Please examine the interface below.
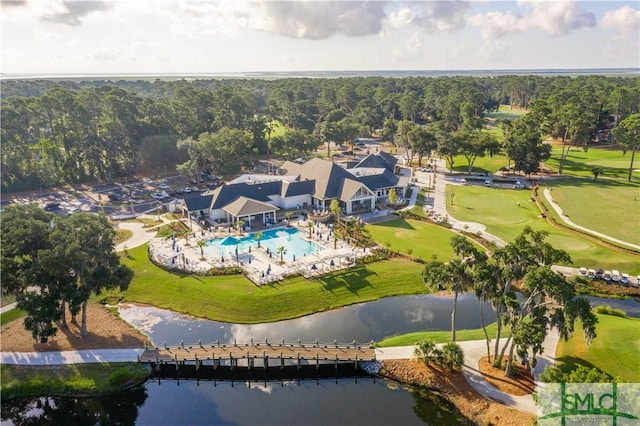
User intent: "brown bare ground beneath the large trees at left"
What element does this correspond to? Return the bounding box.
[0,303,148,352]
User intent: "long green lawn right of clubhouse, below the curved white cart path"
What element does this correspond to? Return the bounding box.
[447,185,640,275]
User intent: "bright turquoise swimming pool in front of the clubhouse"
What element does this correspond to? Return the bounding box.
[205,228,322,260]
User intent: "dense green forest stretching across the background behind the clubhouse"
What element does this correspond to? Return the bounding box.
[1,76,640,190]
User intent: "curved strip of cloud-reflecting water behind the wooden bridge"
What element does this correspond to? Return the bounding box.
[120,294,495,345]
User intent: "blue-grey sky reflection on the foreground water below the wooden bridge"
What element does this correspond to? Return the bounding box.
[132,379,461,425]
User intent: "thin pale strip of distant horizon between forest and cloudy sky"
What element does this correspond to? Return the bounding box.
[0,67,640,80]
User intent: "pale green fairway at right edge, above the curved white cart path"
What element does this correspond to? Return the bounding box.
[540,178,640,244]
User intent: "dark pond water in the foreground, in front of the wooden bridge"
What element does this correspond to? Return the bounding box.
[2,379,460,426]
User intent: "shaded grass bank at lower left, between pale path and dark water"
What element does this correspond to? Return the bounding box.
[0,363,149,400]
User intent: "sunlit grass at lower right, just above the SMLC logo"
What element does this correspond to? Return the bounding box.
[556,314,640,383]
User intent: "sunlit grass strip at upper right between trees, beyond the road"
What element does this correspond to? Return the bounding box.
[545,144,640,182]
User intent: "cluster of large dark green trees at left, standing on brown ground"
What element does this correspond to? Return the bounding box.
[0,204,133,343]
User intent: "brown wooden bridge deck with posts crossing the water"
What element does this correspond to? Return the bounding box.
[139,342,376,366]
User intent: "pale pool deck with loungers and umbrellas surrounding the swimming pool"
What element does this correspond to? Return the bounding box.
[149,220,370,285]
